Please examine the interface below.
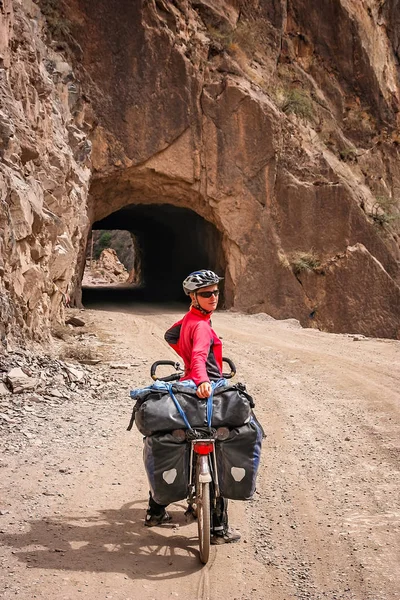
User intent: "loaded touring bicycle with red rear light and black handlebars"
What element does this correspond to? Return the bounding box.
[150,357,236,564]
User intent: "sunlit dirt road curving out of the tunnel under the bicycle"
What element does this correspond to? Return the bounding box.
[0,306,400,600]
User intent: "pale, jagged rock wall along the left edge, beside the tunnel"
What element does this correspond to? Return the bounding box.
[0,0,91,343]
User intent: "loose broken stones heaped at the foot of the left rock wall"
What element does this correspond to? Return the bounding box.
[0,350,129,454]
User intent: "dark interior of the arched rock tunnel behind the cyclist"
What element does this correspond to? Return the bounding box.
[82,204,225,307]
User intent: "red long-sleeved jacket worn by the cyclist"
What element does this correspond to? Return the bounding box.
[164,306,222,385]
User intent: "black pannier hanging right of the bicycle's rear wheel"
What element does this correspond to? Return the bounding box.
[216,418,264,500]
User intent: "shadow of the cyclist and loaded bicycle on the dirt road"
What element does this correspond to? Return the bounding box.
[2,501,202,581]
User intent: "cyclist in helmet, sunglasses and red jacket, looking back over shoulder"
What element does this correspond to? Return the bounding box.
[145,269,240,544]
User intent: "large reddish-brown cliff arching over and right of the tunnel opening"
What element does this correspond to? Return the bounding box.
[68,0,400,337]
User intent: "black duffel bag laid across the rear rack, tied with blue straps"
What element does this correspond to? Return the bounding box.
[133,383,254,436]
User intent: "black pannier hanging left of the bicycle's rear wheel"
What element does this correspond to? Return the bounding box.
[143,433,190,504]
